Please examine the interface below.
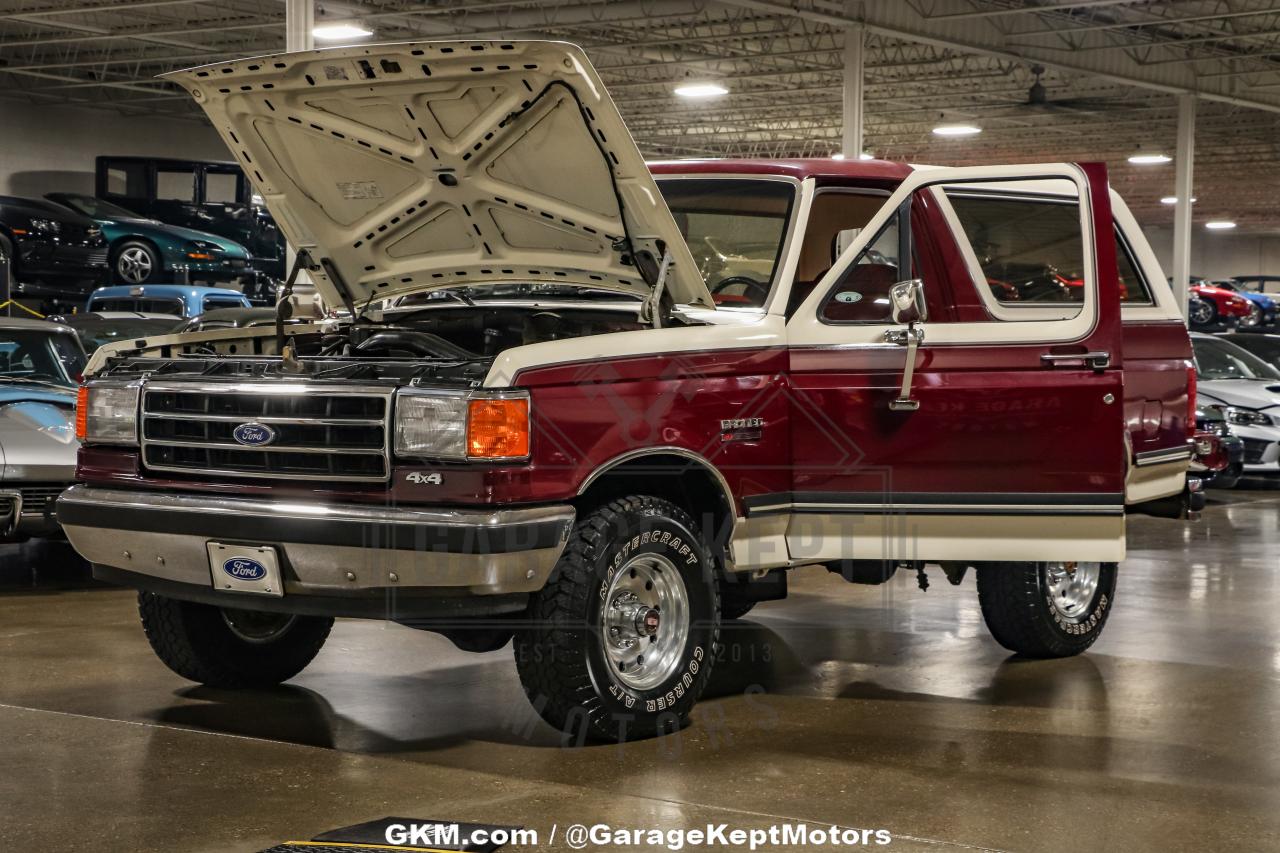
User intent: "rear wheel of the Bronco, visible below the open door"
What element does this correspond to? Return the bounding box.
[978,562,1116,657]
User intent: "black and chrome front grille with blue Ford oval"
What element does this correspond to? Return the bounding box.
[142,384,390,482]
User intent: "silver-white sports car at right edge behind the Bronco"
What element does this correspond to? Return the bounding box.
[1192,333,1280,474]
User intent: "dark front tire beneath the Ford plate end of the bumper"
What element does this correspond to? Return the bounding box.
[138,592,333,688]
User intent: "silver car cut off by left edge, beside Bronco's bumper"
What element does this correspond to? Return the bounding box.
[0,316,86,542]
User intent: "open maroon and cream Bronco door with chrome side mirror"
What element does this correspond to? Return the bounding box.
[773,165,1125,561]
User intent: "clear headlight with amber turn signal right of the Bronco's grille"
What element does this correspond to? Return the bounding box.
[396,391,530,460]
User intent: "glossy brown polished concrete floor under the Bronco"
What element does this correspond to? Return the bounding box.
[0,484,1280,852]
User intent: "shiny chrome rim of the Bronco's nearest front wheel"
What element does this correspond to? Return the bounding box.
[600,553,690,690]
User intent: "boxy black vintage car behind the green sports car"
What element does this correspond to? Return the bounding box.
[95,156,284,292]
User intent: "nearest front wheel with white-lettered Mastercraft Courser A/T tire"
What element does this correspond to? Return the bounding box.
[515,496,719,742]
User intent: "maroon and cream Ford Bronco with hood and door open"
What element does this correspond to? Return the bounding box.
[59,41,1194,738]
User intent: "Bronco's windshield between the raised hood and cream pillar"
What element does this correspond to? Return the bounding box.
[658,178,795,309]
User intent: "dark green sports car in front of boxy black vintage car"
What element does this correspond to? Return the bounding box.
[45,192,259,289]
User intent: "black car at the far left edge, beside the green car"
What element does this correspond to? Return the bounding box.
[0,196,106,302]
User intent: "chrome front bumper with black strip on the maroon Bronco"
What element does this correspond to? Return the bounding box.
[58,485,575,604]
